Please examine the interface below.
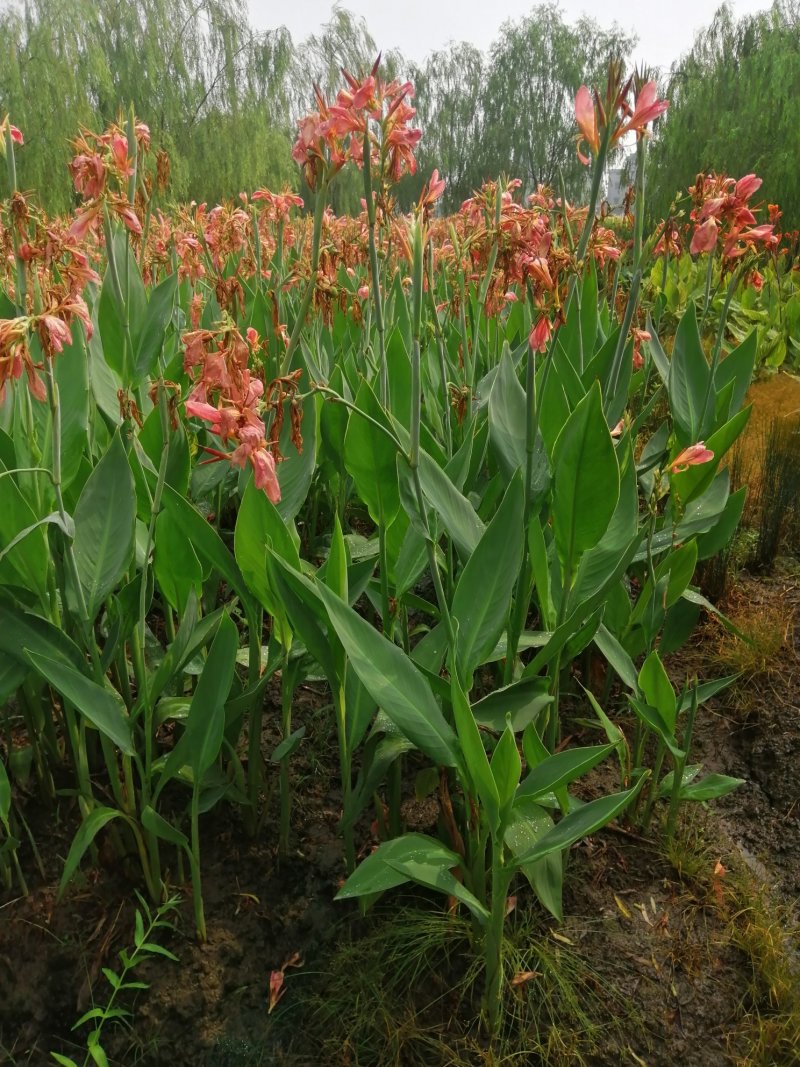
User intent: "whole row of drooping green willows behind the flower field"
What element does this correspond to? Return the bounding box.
[0,0,800,228]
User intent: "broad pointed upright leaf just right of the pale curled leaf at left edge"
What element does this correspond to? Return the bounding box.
[75,430,137,619]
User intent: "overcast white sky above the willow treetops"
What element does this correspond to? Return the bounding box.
[249,0,771,77]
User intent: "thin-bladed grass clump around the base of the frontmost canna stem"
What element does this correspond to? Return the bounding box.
[266,905,624,1067]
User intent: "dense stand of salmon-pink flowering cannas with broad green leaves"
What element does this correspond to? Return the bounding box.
[0,50,771,1032]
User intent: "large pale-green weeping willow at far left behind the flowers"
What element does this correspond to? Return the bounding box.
[0,0,293,210]
